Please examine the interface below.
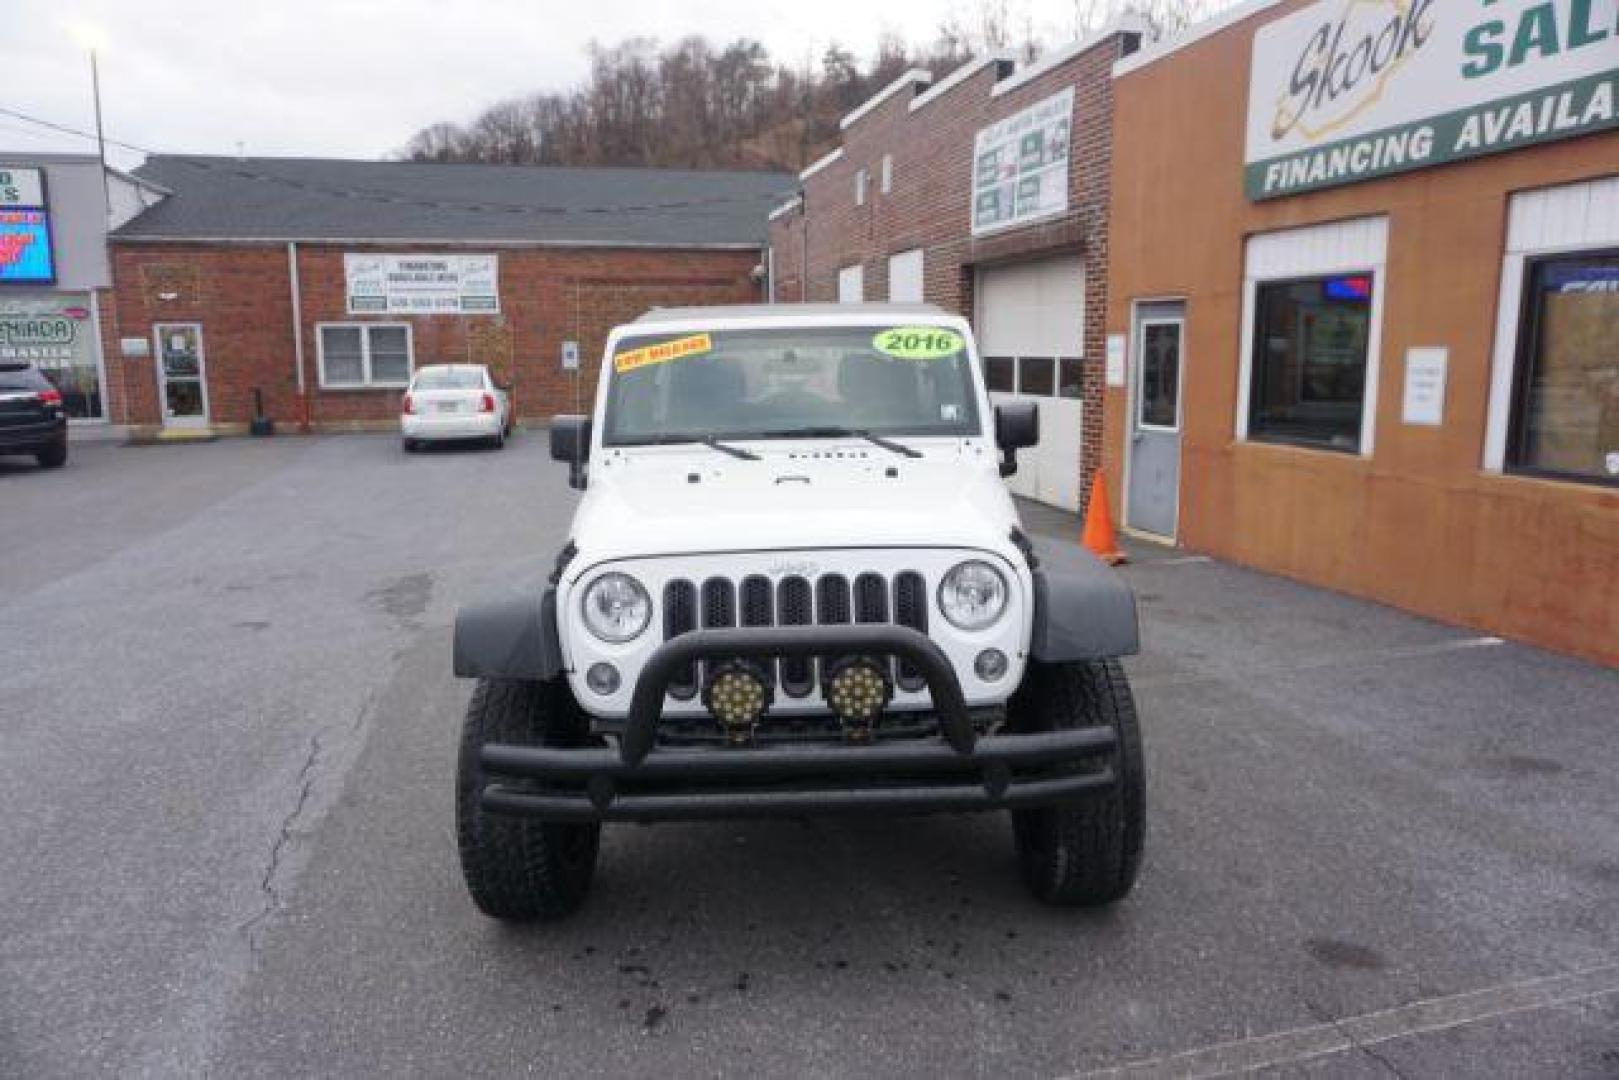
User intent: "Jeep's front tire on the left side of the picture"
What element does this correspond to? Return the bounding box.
[455,678,601,923]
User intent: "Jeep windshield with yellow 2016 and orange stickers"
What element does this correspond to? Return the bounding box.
[602,324,981,447]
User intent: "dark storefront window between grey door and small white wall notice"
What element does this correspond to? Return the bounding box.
[1248,274,1373,452]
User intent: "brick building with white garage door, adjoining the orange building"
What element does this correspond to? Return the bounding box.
[769,19,1143,510]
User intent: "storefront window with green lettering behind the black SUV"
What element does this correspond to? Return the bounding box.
[0,293,107,419]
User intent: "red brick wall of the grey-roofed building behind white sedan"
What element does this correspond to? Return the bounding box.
[108,241,761,427]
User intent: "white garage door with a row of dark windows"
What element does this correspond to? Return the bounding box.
[976,257,1085,510]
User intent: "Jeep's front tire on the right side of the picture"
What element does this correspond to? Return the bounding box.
[1010,661,1146,907]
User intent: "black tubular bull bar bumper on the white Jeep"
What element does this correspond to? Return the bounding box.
[481,625,1117,823]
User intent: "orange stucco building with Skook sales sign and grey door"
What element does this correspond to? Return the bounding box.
[1104,0,1619,664]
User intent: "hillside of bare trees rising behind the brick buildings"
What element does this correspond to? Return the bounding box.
[400,0,1229,170]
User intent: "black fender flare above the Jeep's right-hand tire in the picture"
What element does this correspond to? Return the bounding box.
[1030,539,1141,664]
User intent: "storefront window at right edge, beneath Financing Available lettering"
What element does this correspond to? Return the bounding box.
[1509,251,1619,484]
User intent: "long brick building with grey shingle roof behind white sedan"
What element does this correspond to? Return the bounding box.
[107,155,792,431]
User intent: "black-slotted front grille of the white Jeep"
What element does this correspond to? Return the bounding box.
[664,570,928,701]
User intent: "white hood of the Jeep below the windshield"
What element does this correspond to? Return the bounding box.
[573,452,1017,570]
